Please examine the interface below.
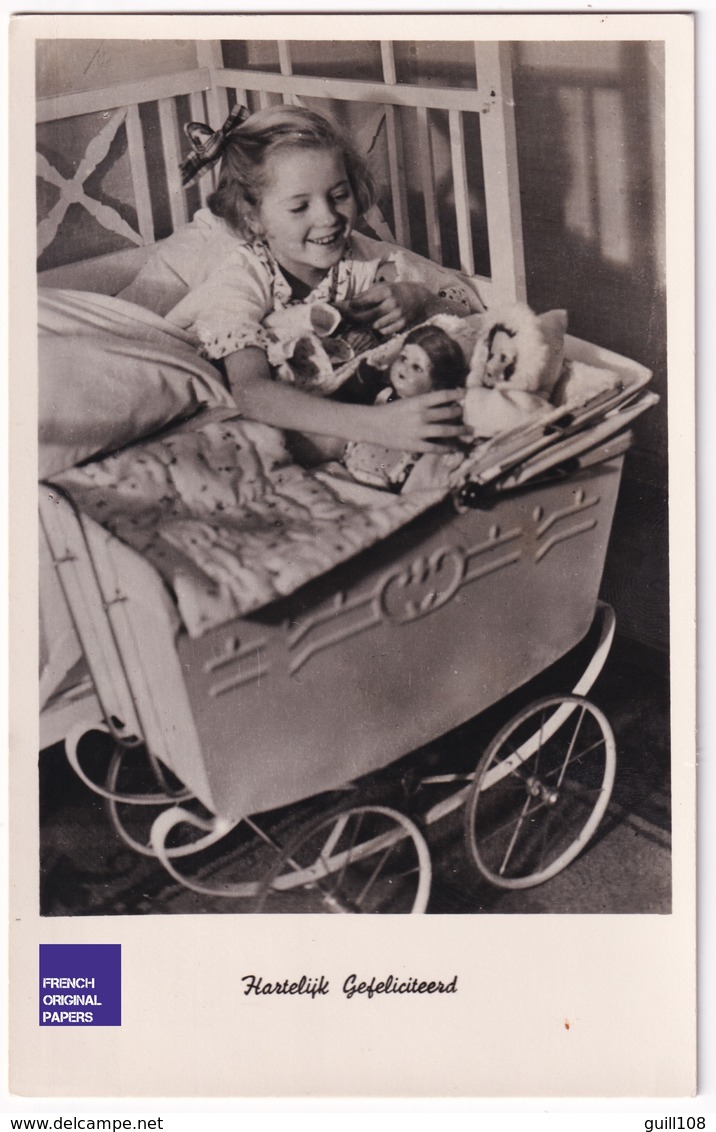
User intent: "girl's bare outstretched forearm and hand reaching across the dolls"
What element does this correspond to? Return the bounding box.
[224,346,472,452]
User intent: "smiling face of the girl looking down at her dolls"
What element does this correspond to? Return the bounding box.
[251,148,357,288]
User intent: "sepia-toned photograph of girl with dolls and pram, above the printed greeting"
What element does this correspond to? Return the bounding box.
[36,30,671,916]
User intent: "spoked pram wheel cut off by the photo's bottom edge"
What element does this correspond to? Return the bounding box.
[256,806,432,915]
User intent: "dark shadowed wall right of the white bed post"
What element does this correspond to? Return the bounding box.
[515,43,668,648]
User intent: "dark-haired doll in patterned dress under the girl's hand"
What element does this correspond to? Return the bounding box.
[343,325,467,491]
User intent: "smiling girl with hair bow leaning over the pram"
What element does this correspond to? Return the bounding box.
[121,105,483,455]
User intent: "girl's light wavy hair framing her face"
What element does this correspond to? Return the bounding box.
[207,105,373,235]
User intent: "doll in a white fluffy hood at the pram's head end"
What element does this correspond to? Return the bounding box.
[465,303,566,438]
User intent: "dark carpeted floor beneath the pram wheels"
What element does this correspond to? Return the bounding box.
[40,638,671,916]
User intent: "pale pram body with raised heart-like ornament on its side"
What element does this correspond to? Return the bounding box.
[43,441,621,818]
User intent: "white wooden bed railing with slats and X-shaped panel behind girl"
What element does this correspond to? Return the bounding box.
[37,41,525,301]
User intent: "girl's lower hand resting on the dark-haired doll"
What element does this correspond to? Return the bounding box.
[370,389,473,452]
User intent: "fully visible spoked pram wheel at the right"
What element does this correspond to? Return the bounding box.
[465,696,616,889]
